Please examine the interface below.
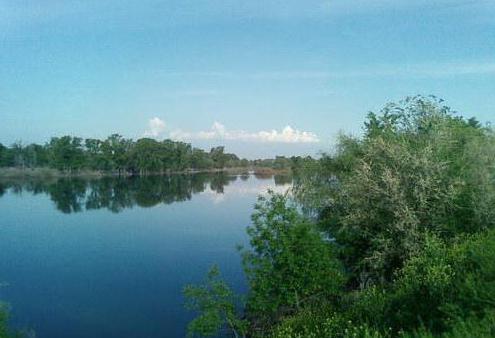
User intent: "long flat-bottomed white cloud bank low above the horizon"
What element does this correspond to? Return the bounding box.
[170,122,319,143]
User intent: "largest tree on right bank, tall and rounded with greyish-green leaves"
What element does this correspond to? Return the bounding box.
[295,97,495,286]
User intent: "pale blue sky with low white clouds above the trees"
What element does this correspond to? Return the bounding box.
[0,0,495,158]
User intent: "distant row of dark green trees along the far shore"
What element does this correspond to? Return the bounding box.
[0,134,311,175]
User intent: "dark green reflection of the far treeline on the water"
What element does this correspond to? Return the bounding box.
[0,173,252,214]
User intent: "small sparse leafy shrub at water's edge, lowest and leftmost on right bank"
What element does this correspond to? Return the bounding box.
[184,266,247,337]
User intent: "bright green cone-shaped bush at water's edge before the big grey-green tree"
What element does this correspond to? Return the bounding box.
[242,193,344,322]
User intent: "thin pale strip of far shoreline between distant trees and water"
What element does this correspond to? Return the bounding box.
[0,167,291,178]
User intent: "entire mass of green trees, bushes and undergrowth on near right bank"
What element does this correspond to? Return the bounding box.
[185,96,495,338]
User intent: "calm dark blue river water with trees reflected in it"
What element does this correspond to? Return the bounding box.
[0,174,290,338]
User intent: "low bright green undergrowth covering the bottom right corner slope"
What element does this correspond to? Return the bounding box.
[269,230,495,337]
